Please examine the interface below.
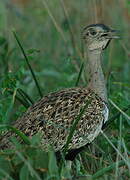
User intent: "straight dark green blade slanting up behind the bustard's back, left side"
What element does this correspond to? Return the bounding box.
[13,31,42,98]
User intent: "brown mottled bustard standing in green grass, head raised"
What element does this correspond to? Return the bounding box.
[0,24,118,160]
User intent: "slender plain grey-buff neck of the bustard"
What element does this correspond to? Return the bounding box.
[87,50,107,102]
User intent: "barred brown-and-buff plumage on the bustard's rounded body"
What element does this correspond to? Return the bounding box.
[0,88,107,151]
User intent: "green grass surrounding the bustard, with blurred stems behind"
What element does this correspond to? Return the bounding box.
[0,0,130,180]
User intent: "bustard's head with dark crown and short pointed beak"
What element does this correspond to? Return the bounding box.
[83,24,119,51]
